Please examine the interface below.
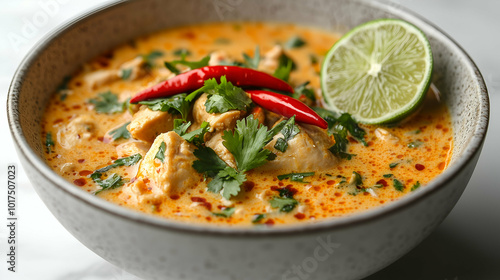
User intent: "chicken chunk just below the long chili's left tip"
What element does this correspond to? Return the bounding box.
[127,105,175,143]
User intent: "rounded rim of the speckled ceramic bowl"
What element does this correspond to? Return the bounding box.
[7,0,490,237]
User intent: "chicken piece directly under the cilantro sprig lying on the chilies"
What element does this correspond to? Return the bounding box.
[193,93,245,132]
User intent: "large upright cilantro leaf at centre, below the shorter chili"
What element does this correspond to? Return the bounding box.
[222,115,271,172]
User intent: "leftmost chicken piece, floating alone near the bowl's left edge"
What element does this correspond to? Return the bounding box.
[57,114,97,149]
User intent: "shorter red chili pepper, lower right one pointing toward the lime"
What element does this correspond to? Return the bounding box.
[246,90,328,129]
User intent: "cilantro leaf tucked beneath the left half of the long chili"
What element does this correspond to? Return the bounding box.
[139,93,191,120]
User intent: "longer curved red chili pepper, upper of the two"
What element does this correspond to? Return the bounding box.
[130,66,293,103]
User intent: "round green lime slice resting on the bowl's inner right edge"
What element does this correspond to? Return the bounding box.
[321,19,433,124]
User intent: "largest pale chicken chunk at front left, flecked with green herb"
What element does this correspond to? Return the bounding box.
[124,131,202,203]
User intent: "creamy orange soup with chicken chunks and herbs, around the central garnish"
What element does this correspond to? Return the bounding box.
[42,23,453,226]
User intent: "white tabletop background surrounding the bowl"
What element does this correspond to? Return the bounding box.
[0,0,500,280]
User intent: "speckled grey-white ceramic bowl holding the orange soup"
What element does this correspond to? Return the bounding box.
[7,0,489,279]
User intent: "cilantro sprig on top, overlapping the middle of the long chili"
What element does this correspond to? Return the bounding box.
[205,76,252,113]
